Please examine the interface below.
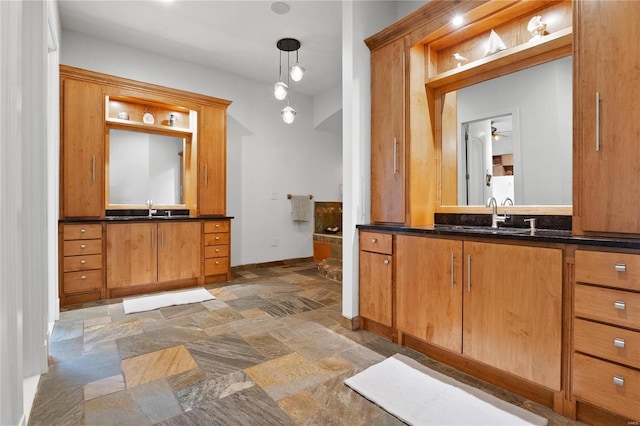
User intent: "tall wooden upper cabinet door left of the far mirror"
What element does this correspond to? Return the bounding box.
[61,79,104,217]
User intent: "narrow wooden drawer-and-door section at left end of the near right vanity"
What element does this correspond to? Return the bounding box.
[359,231,394,332]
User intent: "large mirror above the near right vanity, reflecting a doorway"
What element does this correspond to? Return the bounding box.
[441,56,573,206]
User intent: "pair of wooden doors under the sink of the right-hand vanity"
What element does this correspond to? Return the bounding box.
[396,235,563,391]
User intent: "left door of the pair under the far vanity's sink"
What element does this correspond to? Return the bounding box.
[107,223,158,288]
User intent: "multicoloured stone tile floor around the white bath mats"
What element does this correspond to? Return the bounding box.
[29,263,576,426]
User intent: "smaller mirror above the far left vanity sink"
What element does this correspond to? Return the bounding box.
[107,128,188,206]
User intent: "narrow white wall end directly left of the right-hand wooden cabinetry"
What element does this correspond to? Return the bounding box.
[342,0,398,318]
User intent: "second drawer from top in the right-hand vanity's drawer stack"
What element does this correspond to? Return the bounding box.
[575,284,640,329]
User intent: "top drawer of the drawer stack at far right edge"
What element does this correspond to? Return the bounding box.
[576,250,640,291]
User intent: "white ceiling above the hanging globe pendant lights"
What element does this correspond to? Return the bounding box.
[59,0,342,96]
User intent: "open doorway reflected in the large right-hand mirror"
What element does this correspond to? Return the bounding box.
[462,114,515,205]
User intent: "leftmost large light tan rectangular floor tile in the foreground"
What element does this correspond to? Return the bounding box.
[122,345,198,388]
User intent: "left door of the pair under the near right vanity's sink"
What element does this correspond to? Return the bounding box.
[396,235,462,353]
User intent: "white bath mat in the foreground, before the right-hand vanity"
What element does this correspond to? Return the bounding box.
[344,354,547,426]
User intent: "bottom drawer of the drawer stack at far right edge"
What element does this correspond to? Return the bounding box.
[573,354,640,420]
